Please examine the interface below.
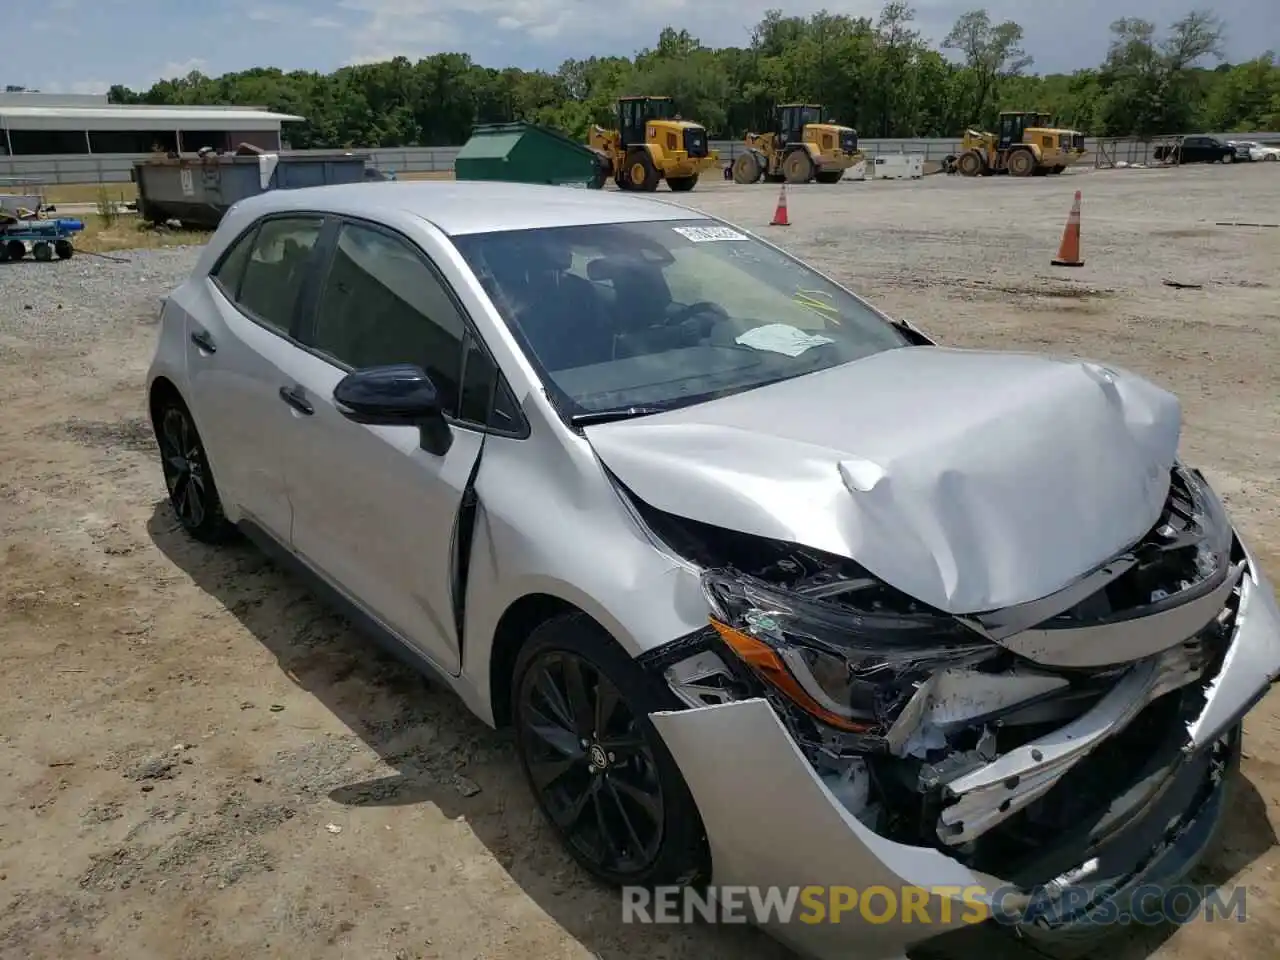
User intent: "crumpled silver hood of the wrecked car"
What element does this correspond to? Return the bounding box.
[585,346,1181,614]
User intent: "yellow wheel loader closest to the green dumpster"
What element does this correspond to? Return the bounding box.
[586,97,719,192]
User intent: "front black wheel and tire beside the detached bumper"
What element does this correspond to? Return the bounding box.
[511,613,710,887]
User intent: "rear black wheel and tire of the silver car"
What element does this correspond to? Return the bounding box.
[152,397,234,544]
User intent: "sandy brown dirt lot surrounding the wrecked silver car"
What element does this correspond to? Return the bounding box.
[0,166,1280,960]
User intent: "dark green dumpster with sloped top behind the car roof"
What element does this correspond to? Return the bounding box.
[453,123,607,189]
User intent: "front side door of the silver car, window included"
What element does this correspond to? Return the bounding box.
[277,221,483,673]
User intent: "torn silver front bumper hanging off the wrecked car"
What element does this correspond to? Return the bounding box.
[652,529,1280,960]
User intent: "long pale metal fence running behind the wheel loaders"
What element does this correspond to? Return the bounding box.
[0,133,1280,187]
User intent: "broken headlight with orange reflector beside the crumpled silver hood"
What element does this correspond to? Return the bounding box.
[703,571,1000,737]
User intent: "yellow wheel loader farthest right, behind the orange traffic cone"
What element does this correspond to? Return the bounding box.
[942,111,1084,177]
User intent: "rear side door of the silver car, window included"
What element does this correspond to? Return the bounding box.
[187,215,323,543]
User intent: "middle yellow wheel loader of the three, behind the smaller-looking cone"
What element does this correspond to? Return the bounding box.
[733,104,863,183]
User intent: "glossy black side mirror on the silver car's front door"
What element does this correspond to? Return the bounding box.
[333,364,453,457]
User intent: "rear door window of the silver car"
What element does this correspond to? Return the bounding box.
[236,218,320,333]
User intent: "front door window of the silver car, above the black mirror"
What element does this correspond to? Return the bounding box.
[312,224,465,413]
